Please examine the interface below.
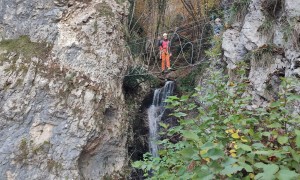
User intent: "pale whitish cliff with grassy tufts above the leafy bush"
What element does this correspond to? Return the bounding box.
[222,0,300,105]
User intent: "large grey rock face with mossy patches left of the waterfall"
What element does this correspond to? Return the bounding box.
[0,0,130,179]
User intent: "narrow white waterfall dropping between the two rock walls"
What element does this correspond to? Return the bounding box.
[148,81,174,157]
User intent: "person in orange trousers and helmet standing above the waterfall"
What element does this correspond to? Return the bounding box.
[159,33,172,72]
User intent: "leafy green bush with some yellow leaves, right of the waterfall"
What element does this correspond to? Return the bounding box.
[132,68,300,180]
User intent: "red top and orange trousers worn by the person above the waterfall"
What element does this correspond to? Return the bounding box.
[159,40,171,71]
